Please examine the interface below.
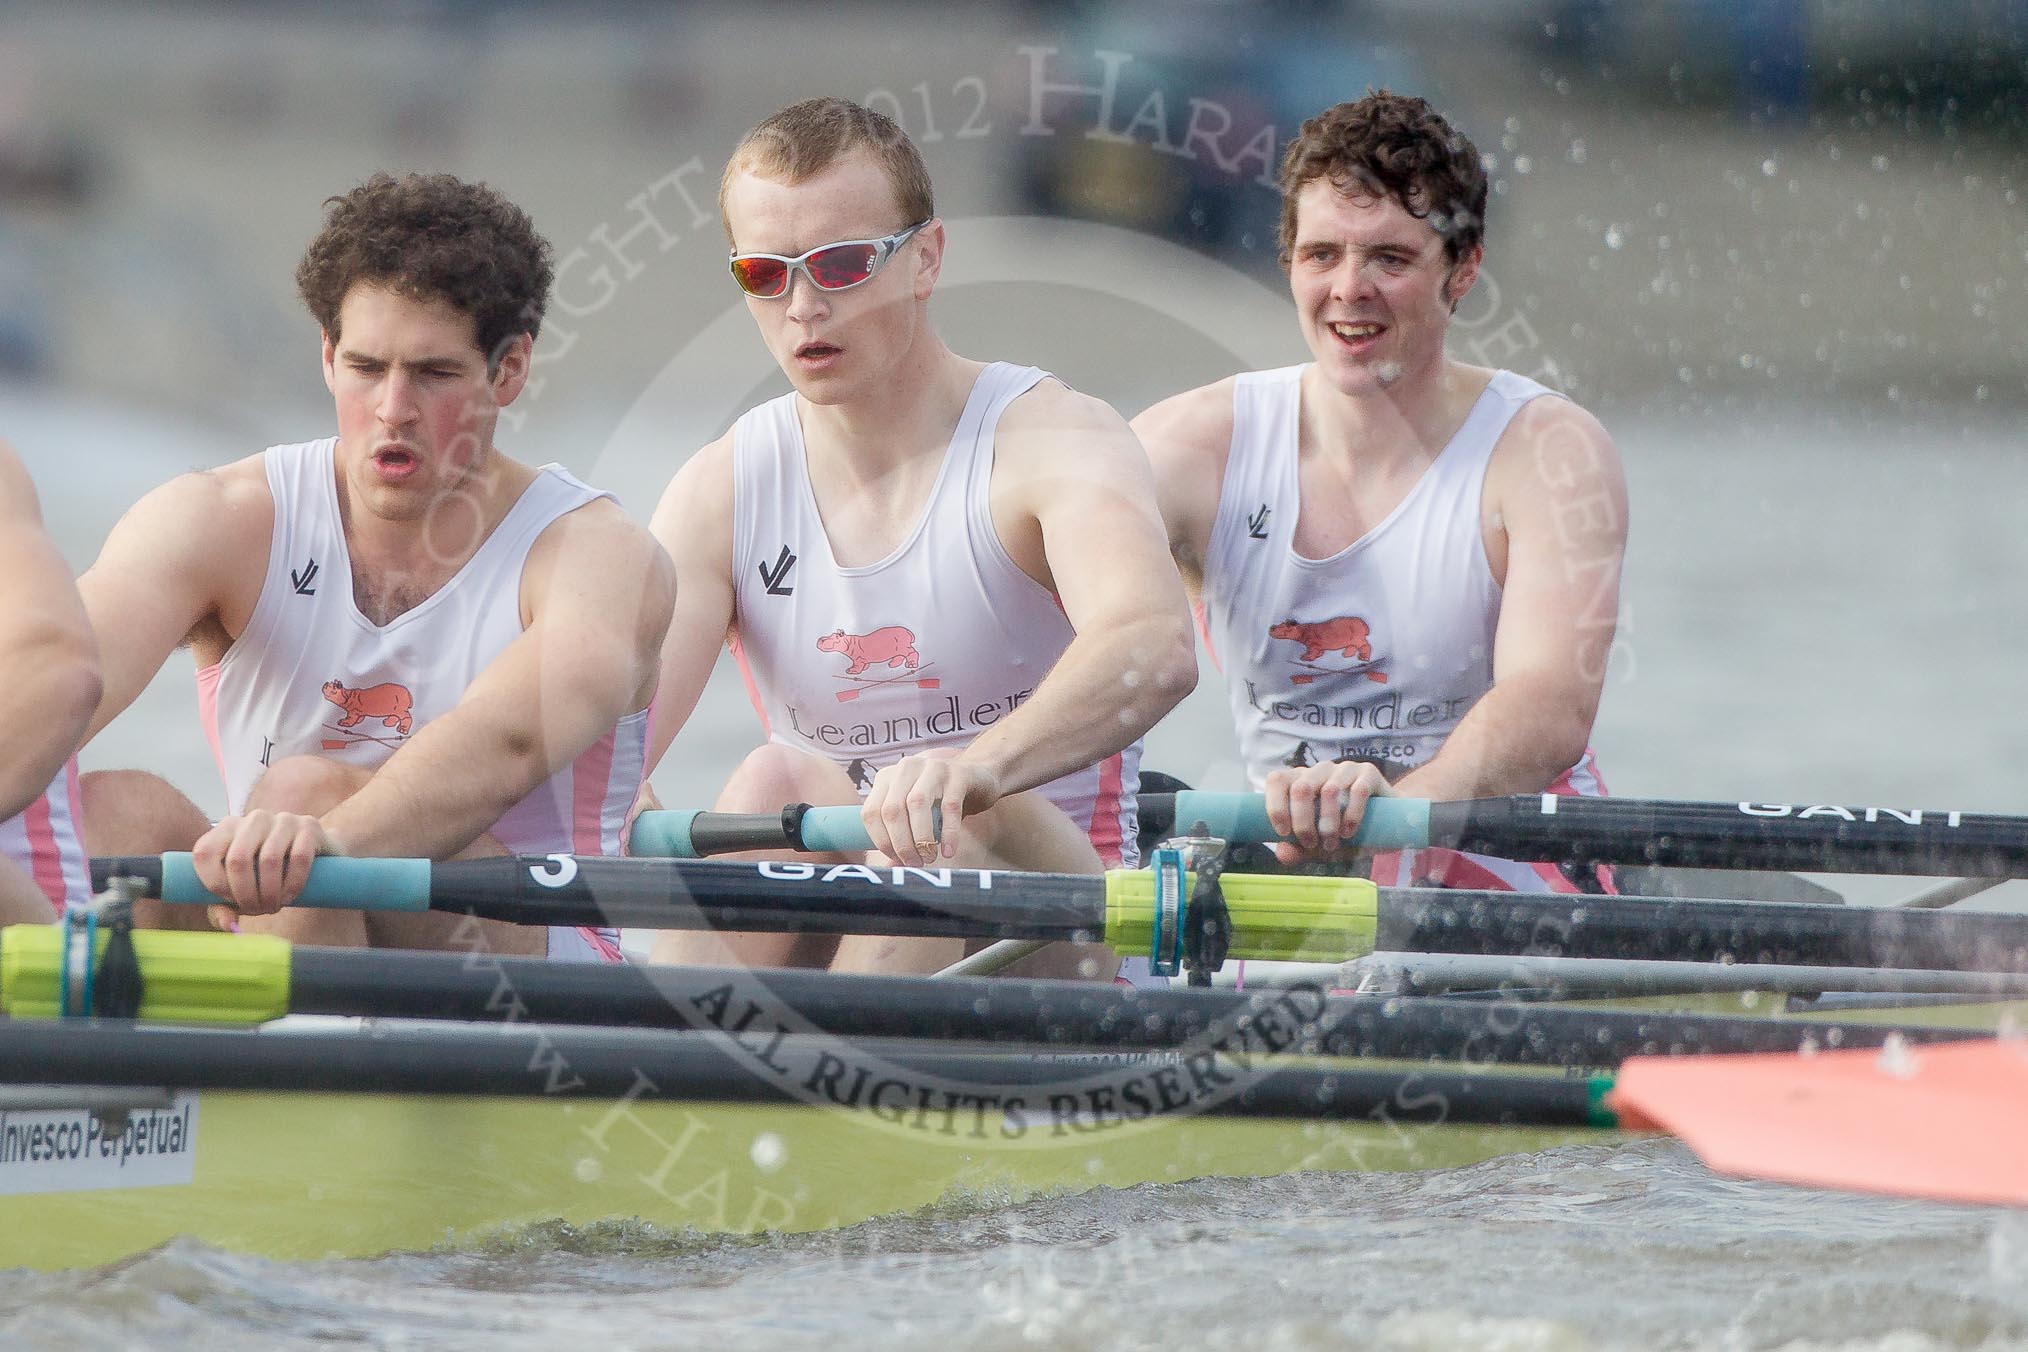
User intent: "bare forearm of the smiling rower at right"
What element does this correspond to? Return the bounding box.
[1395,675,1596,801]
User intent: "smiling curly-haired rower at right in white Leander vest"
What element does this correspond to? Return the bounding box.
[1134,91,1626,892]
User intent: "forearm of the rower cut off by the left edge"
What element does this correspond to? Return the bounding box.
[0,624,99,821]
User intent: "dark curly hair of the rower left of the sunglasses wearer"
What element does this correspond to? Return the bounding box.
[296,174,554,371]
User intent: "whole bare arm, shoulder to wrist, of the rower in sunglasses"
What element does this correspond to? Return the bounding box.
[957,383,1197,795]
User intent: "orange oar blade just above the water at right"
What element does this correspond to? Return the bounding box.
[1606,1040,2028,1206]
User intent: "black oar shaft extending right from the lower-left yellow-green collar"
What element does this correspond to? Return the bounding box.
[290,949,1975,1066]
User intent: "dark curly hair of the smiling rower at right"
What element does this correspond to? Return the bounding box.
[1280,89,1487,268]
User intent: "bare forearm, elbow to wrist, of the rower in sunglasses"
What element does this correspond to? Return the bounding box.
[959,616,1197,795]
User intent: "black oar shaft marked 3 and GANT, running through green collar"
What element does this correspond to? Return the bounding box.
[93,857,2028,971]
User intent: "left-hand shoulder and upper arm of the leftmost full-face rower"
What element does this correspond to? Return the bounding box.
[77,456,274,738]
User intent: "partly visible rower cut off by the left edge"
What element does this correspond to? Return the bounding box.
[0,444,99,924]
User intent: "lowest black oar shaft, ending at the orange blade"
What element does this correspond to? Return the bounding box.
[0,1024,1604,1139]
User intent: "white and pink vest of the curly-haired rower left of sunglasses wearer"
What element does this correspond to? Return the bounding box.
[197,438,647,961]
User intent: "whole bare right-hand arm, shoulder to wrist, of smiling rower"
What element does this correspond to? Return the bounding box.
[1397,399,1626,799]
